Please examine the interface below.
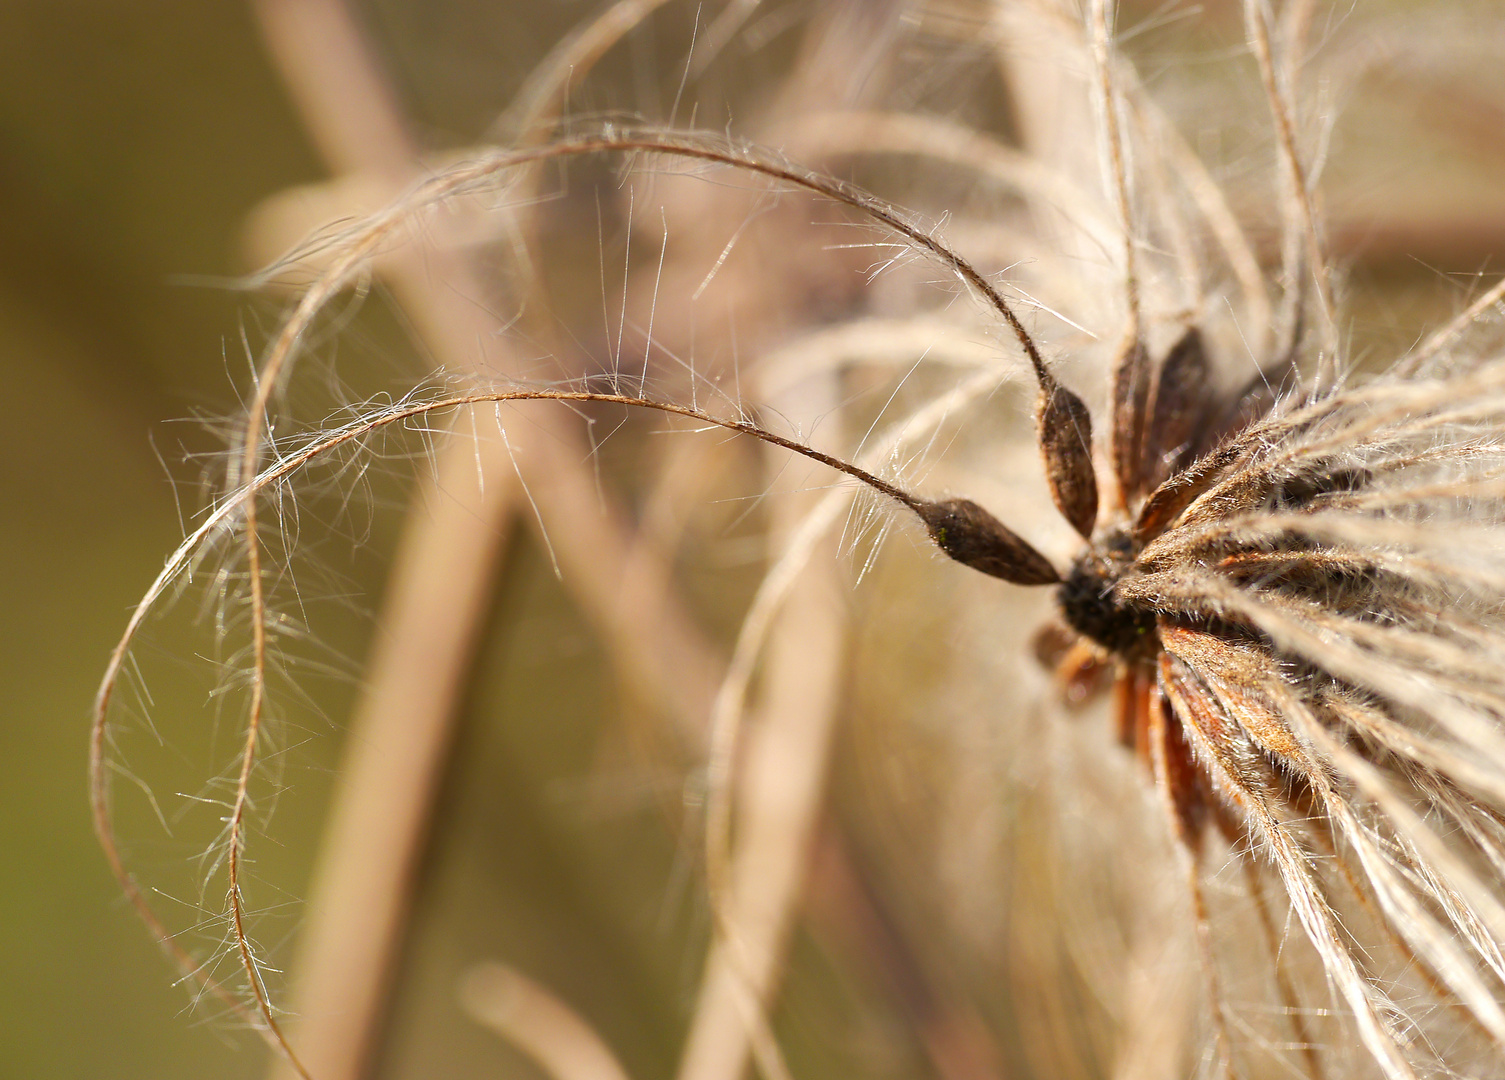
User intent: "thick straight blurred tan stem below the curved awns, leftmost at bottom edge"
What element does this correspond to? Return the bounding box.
[274,453,523,1080]
